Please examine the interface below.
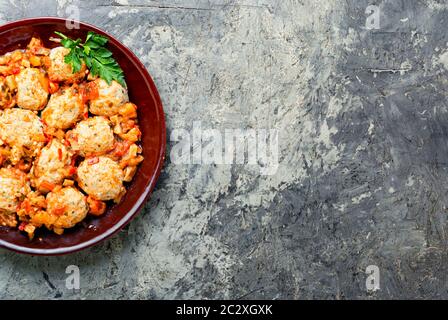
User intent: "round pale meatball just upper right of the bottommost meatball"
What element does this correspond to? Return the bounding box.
[78,156,125,202]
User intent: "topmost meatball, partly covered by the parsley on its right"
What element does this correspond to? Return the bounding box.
[48,47,86,83]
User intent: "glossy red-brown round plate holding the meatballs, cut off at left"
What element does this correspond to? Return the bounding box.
[0,17,166,255]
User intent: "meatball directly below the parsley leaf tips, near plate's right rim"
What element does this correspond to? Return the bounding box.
[90,79,129,117]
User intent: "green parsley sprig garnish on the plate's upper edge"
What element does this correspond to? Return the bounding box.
[55,31,126,87]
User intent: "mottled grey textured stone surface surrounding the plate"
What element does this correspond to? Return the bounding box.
[0,0,448,299]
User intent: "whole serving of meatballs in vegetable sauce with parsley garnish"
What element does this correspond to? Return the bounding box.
[0,32,143,239]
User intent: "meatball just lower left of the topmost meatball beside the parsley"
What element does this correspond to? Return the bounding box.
[16,68,48,111]
